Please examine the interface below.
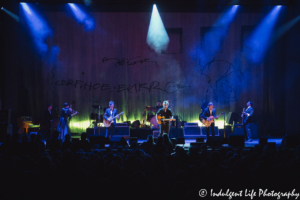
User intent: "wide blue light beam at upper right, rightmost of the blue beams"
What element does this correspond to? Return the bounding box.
[244,6,281,63]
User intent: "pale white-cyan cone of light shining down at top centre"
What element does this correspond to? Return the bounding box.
[146,4,170,54]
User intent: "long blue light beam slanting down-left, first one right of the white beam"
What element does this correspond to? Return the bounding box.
[199,5,239,66]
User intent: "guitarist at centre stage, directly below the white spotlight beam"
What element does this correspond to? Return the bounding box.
[155,101,173,136]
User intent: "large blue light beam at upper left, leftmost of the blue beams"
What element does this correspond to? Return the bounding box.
[20,3,52,53]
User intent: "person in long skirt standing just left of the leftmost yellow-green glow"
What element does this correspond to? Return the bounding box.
[57,103,73,140]
